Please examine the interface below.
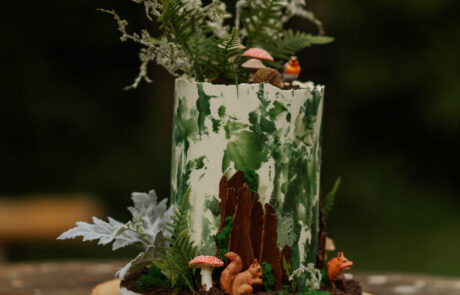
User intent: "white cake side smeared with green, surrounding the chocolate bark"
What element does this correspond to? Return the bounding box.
[171,80,323,265]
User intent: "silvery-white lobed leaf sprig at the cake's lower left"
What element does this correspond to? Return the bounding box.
[58,190,174,277]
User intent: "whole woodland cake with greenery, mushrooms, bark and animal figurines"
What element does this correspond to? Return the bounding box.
[59,0,362,295]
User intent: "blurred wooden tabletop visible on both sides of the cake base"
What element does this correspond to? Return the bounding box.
[0,261,460,295]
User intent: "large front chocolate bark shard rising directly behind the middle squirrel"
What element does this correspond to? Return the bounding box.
[229,184,254,269]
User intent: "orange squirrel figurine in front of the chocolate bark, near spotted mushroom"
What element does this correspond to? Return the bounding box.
[220,252,262,295]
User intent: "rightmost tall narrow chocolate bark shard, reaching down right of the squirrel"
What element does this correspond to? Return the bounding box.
[260,203,283,291]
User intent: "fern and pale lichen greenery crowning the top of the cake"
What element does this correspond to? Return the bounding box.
[100,0,333,88]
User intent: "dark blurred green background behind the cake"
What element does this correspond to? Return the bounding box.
[0,0,460,276]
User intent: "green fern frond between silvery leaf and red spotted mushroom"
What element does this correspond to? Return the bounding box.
[154,190,198,293]
